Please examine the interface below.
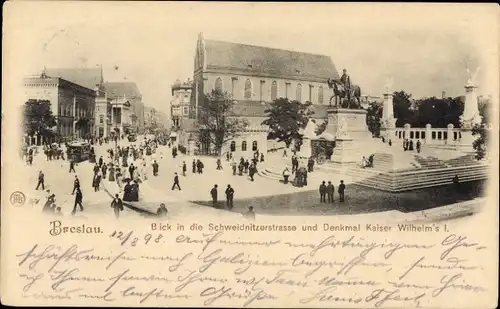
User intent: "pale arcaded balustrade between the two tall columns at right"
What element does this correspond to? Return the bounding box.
[389,124,462,145]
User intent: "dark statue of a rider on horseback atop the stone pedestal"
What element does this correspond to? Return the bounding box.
[327,69,361,109]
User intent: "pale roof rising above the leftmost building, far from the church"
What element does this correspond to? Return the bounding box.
[45,68,103,90]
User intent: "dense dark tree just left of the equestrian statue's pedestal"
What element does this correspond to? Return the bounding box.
[262,98,314,147]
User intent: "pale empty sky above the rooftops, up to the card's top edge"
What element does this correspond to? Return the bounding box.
[3,2,499,113]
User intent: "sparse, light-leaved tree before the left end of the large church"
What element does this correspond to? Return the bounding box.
[198,89,248,155]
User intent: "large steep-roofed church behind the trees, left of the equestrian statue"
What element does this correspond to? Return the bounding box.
[190,34,339,156]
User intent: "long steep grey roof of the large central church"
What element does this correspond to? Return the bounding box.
[205,40,339,82]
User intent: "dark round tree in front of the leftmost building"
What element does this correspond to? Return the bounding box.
[23,99,57,138]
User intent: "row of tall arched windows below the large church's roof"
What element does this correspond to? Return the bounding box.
[214,77,324,104]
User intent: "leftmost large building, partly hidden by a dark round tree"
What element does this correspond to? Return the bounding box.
[24,73,97,140]
